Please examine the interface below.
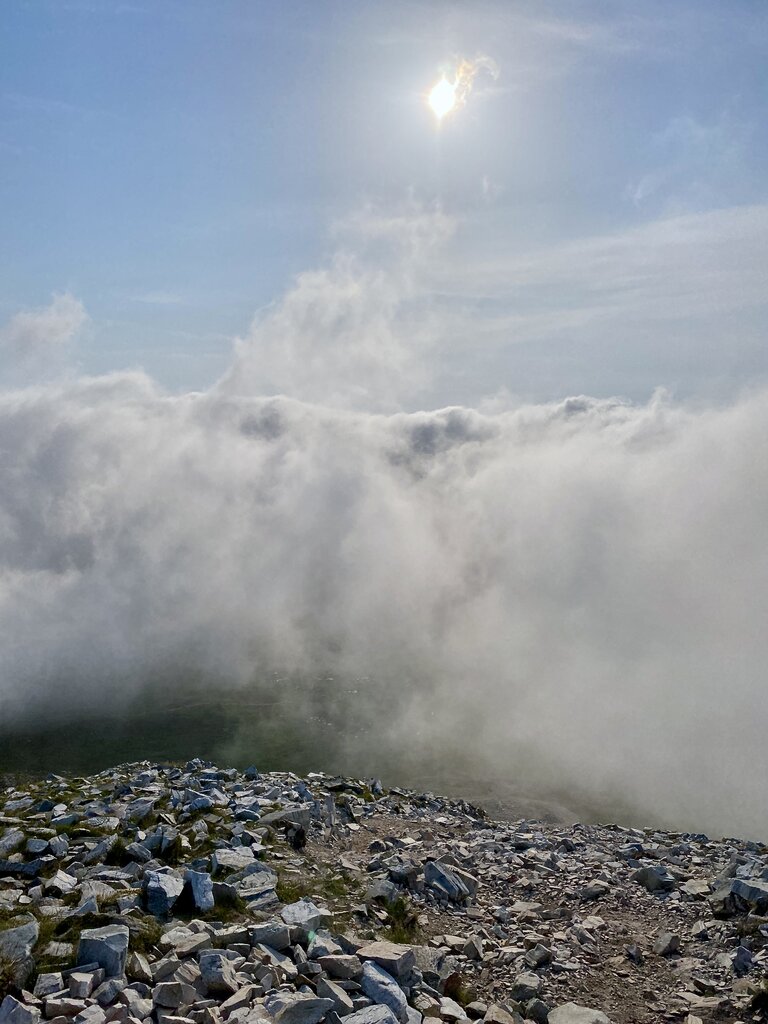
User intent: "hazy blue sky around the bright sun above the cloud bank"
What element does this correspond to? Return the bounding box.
[0,0,768,406]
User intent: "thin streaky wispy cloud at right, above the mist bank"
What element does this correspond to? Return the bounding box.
[430,205,768,383]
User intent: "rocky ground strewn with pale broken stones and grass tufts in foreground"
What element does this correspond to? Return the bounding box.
[0,761,768,1024]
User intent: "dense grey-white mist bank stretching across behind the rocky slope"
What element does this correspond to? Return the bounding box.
[0,364,768,834]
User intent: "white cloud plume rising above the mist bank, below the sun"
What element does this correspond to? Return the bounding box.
[220,208,454,410]
